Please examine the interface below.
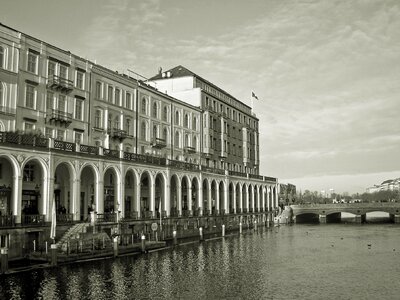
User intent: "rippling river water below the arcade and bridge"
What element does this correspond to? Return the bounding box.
[0,223,400,300]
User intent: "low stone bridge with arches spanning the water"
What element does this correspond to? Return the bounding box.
[290,202,400,223]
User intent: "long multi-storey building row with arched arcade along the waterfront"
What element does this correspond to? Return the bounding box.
[0,25,278,258]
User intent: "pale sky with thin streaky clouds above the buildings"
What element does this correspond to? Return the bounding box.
[0,0,400,193]
